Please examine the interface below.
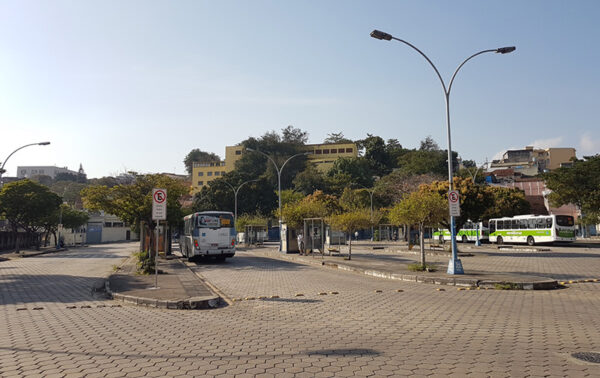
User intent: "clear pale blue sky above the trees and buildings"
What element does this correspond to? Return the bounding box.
[0,0,600,178]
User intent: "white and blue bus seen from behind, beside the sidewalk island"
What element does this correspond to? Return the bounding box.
[179,211,236,261]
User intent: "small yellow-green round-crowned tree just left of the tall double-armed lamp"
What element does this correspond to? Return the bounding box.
[389,191,448,269]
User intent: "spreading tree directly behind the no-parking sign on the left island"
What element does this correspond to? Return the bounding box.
[82,174,189,254]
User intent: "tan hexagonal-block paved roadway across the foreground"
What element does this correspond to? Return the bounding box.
[0,245,600,377]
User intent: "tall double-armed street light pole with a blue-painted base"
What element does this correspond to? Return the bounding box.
[371,30,516,274]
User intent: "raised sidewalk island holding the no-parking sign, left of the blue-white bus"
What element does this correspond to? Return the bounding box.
[106,255,221,310]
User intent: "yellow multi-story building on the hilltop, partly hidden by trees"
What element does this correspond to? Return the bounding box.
[192,143,358,194]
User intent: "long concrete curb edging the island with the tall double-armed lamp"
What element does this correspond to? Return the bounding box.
[258,254,559,290]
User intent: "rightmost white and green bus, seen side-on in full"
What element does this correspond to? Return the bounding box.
[489,215,575,245]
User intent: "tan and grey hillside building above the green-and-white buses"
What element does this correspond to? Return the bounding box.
[488,146,575,176]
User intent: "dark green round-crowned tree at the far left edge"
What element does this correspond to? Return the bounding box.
[0,179,62,252]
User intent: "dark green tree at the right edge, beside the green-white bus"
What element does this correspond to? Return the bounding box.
[543,154,600,224]
